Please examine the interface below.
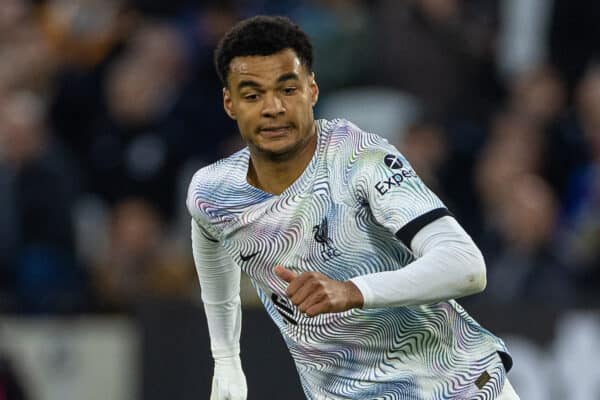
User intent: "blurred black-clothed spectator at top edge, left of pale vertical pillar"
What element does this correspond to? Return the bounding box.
[372,0,497,117]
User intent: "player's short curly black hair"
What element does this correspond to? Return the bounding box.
[214,15,313,86]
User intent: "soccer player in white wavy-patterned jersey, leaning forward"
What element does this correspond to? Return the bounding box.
[187,16,518,400]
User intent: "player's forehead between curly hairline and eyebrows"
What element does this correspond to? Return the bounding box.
[227,49,307,86]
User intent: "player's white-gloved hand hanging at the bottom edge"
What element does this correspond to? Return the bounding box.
[210,356,248,400]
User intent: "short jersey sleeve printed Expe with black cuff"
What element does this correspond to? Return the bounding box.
[350,135,450,248]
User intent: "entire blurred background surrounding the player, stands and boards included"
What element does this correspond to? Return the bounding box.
[0,0,600,400]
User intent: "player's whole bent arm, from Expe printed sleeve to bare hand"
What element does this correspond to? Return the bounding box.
[275,141,486,316]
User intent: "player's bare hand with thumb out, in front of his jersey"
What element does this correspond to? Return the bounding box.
[275,265,364,317]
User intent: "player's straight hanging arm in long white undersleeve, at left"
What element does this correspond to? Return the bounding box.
[192,219,247,400]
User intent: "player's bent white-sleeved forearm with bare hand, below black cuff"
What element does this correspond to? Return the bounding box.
[275,216,486,316]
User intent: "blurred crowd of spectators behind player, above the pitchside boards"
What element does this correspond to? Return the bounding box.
[0,0,600,314]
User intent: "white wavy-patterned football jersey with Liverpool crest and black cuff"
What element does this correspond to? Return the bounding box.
[188,120,506,400]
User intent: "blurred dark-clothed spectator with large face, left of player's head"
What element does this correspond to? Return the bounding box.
[69,24,194,217]
